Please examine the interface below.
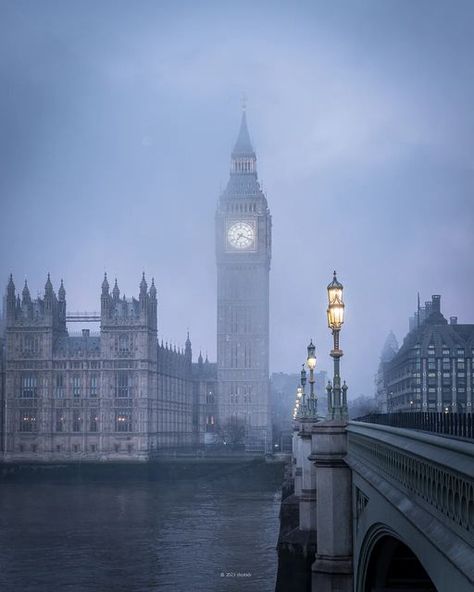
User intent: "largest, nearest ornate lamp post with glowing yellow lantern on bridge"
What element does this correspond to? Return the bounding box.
[326,272,347,420]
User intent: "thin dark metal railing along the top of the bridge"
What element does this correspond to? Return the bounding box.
[355,411,474,440]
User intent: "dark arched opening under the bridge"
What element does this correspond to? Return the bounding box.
[356,524,436,592]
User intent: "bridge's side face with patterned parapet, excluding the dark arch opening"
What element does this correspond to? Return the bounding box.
[346,414,474,591]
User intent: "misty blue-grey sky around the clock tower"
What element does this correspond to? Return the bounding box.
[0,0,474,396]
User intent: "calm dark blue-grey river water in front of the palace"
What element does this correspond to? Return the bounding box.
[0,473,279,592]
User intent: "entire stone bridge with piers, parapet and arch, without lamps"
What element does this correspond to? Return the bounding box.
[277,413,474,592]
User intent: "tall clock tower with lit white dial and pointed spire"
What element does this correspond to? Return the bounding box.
[216,109,271,452]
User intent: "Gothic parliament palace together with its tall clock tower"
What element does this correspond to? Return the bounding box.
[0,110,271,462]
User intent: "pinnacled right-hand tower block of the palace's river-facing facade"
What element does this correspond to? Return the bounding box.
[98,276,157,456]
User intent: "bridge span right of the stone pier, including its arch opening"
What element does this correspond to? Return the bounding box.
[346,422,474,592]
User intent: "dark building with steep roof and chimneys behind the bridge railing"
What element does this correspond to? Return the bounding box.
[383,295,474,412]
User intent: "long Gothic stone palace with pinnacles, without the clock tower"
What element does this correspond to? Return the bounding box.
[0,276,216,461]
